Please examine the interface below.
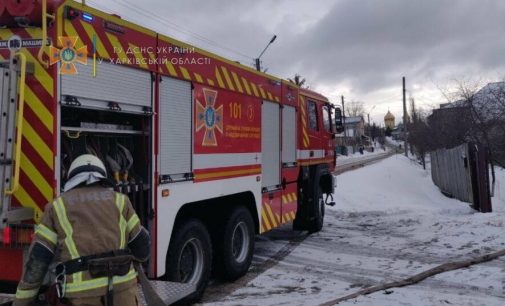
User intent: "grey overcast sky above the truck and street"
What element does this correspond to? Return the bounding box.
[87,0,505,123]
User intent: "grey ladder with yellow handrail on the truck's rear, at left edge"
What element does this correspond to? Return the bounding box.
[0,52,33,235]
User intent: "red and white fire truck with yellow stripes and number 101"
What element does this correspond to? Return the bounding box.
[0,0,341,298]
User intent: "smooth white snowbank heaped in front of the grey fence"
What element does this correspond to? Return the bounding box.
[334,154,471,211]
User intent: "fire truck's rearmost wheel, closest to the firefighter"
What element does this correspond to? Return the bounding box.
[165,219,212,305]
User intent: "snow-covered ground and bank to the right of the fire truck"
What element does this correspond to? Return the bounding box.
[204,155,505,306]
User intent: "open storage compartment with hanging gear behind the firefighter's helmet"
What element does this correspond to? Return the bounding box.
[60,106,152,228]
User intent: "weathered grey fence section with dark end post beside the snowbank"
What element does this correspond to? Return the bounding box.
[430,143,491,212]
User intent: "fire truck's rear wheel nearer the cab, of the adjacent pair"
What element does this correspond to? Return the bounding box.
[215,206,255,281]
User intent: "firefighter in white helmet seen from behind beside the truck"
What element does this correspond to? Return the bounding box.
[14,154,150,305]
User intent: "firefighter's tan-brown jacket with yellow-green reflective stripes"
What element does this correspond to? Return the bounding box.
[16,186,142,300]
